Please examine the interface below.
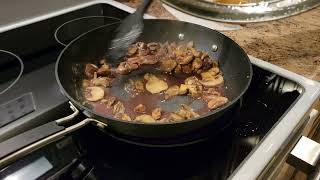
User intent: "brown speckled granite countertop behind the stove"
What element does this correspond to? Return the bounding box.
[118,0,320,81]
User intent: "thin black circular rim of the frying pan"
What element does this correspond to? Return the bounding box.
[55,19,253,126]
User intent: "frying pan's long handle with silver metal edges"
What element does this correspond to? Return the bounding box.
[0,103,107,169]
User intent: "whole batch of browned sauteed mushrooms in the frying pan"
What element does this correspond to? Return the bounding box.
[82,41,228,123]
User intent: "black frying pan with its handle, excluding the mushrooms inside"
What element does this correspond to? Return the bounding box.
[0,20,252,167]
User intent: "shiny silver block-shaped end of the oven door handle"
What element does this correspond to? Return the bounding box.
[287,136,320,180]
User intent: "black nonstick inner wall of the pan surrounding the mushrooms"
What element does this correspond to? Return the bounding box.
[56,20,252,135]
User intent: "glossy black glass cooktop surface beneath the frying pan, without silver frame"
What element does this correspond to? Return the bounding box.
[0,4,301,180]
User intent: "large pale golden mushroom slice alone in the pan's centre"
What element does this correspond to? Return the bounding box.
[146,75,168,94]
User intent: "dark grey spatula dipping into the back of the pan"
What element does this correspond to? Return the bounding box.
[106,0,151,64]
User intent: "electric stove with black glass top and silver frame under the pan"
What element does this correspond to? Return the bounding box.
[0,1,320,179]
